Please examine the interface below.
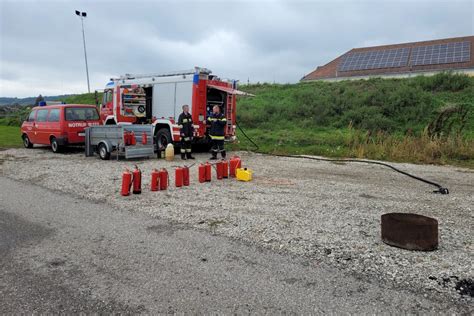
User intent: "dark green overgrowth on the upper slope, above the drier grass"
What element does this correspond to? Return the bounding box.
[237,73,474,134]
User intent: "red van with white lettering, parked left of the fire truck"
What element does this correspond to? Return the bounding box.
[21,104,101,153]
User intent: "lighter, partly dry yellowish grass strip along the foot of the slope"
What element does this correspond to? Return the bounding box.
[230,128,474,169]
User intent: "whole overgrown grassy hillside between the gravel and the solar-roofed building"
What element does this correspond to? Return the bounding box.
[237,73,474,166]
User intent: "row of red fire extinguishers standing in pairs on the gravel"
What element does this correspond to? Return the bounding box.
[120,156,242,196]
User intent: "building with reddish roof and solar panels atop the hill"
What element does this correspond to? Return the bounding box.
[301,36,474,81]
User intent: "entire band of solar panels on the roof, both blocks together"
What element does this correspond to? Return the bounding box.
[338,42,471,71]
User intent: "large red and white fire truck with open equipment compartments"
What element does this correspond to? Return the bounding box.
[100,67,246,147]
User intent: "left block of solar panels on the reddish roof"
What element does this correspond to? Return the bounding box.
[339,48,410,71]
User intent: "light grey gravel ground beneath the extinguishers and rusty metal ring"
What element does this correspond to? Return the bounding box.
[0,148,474,304]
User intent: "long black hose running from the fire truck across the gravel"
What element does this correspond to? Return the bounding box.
[235,121,449,194]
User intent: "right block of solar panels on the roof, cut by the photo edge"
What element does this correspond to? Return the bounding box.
[410,42,471,66]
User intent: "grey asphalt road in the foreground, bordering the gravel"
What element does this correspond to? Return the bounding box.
[0,177,467,314]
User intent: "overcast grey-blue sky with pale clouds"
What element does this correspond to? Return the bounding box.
[0,0,474,97]
